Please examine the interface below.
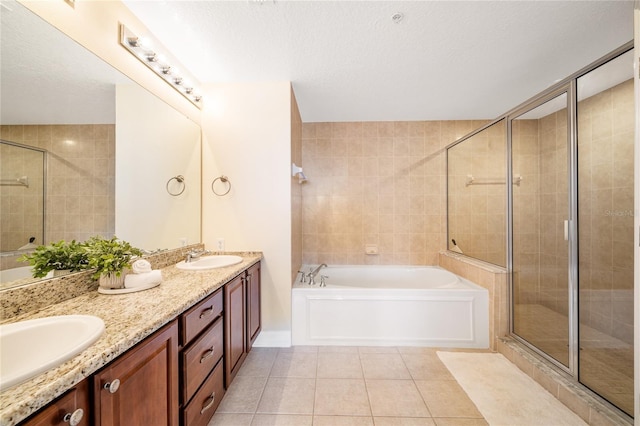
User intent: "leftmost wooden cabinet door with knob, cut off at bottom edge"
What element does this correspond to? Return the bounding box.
[20,380,92,426]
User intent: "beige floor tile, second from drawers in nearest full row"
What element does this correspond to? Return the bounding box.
[255,377,316,414]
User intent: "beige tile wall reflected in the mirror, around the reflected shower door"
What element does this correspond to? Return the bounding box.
[0,124,115,266]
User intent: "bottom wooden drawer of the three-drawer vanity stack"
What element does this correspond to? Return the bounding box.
[182,362,224,426]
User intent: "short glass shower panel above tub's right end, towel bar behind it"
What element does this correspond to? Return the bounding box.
[447,119,508,267]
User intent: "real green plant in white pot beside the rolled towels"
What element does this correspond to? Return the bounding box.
[86,236,142,288]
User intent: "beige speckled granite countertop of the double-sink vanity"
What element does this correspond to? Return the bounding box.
[0,253,262,426]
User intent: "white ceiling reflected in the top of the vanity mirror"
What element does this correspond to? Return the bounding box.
[0,0,131,124]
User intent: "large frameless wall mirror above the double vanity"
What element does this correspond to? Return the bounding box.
[0,1,201,289]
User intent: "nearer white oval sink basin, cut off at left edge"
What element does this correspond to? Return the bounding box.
[0,315,104,391]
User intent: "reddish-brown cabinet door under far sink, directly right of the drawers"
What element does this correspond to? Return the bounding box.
[224,274,247,388]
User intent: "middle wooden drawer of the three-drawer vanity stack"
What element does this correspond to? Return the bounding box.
[181,319,224,404]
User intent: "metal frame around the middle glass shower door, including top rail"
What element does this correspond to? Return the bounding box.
[504,40,637,386]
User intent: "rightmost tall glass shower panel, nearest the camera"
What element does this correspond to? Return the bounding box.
[577,51,635,416]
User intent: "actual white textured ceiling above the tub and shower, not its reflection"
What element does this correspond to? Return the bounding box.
[124,0,633,122]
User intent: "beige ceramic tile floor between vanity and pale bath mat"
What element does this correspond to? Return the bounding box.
[209,346,488,426]
